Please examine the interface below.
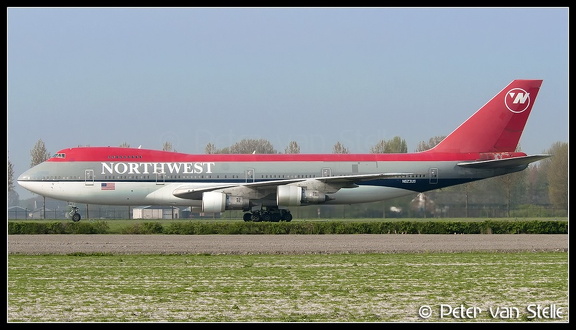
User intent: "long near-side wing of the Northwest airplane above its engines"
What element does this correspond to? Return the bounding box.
[172,173,412,199]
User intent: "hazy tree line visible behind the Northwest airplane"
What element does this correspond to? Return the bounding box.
[7,136,568,217]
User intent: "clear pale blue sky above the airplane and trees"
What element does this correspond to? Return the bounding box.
[7,7,569,199]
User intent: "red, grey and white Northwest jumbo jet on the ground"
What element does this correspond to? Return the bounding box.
[18,80,550,222]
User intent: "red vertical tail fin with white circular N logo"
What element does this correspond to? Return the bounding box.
[430,80,542,152]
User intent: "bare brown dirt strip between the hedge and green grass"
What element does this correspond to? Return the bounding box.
[8,234,568,254]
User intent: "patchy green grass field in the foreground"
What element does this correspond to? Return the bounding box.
[7,252,568,322]
